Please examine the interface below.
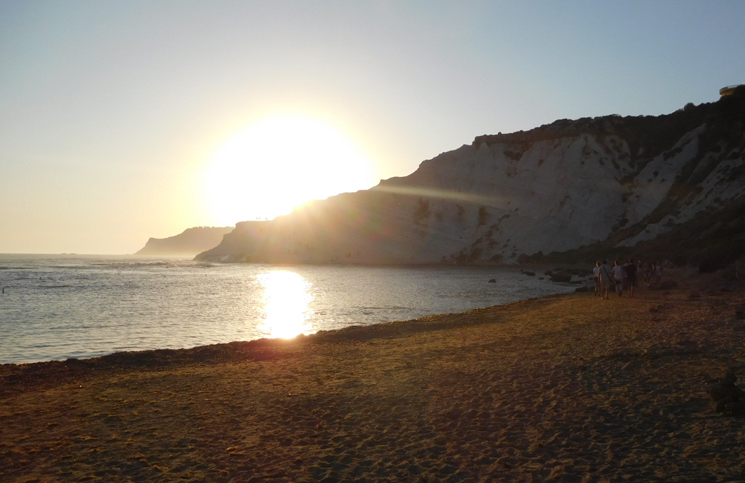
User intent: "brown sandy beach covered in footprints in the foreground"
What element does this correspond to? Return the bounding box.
[0,279,745,482]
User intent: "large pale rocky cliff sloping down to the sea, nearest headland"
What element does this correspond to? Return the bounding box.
[198,88,745,264]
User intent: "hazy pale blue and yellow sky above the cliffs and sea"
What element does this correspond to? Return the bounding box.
[0,0,745,254]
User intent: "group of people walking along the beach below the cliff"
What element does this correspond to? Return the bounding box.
[592,258,662,299]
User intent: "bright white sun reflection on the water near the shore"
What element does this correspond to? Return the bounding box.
[258,271,313,339]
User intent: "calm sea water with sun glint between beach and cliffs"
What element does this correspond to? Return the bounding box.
[0,255,575,364]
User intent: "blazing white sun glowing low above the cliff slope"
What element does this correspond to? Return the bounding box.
[205,116,375,225]
